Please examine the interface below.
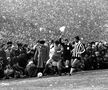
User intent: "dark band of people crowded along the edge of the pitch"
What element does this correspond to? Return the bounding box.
[0,36,108,79]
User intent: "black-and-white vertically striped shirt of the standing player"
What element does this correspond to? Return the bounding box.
[73,41,85,57]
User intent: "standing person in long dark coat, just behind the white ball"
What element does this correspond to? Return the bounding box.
[34,40,48,73]
